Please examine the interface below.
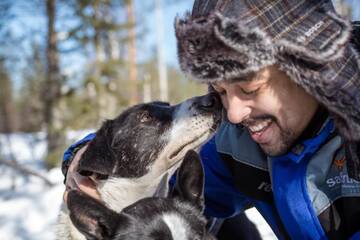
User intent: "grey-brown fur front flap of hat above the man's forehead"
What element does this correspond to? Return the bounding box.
[175,14,275,82]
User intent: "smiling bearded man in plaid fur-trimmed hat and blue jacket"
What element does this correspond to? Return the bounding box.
[62,0,360,239]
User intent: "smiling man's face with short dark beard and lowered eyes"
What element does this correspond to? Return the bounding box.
[212,66,318,156]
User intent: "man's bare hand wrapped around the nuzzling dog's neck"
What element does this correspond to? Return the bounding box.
[64,145,100,202]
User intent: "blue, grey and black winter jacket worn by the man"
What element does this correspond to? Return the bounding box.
[63,119,360,239]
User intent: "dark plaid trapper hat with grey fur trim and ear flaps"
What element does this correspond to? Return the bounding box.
[175,0,360,140]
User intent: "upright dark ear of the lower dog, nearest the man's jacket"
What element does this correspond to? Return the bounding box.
[175,150,204,210]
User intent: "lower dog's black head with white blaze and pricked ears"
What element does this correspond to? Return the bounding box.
[68,150,215,240]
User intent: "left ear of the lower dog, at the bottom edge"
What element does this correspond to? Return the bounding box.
[67,190,130,239]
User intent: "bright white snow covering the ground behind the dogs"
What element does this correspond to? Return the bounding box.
[0,131,276,240]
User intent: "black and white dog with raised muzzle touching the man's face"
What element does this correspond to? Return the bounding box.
[56,93,222,239]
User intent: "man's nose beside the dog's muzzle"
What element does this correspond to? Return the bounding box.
[226,96,251,124]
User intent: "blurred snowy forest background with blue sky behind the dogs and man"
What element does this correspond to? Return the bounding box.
[0,0,360,240]
